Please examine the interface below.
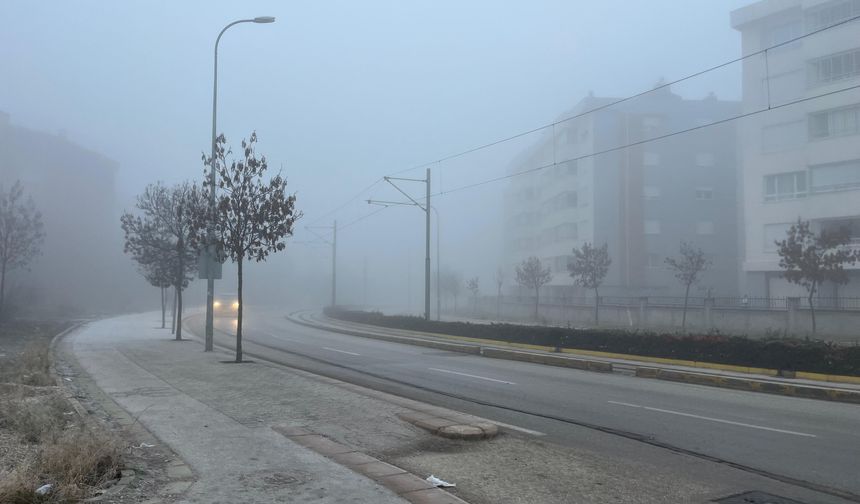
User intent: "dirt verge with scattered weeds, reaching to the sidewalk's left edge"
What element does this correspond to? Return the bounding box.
[0,321,176,503]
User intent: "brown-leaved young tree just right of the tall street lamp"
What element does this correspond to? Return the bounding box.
[201,132,302,362]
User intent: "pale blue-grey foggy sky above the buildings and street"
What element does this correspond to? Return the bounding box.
[0,0,749,312]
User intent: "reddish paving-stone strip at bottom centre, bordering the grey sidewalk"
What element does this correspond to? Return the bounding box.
[272,424,468,504]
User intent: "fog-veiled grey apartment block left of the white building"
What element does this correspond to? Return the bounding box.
[504,87,740,296]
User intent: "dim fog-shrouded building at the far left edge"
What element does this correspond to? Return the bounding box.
[0,112,127,311]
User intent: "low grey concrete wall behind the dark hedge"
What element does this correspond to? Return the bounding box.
[466,297,860,344]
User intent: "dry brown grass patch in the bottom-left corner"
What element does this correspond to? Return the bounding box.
[0,324,123,504]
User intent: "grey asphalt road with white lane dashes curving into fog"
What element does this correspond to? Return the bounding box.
[203,312,860,502]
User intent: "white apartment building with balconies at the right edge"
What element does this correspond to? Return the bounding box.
[731,0,860,296]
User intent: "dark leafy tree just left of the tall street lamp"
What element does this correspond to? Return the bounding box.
[120,182,206,340]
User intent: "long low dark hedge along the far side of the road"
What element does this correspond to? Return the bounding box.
[326,308,860,376]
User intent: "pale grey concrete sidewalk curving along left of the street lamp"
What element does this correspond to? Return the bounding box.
[66,314,418,503]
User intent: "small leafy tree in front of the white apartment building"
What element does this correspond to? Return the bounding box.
[775,219,860,334]
